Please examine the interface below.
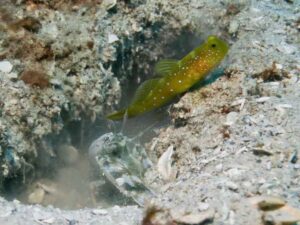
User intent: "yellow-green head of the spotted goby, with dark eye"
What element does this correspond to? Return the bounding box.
[202,35,229,64]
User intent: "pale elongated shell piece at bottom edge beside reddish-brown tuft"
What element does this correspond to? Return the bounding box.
[171,209,215,224]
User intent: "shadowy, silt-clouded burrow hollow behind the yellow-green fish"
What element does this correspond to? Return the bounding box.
[2,27,207,209]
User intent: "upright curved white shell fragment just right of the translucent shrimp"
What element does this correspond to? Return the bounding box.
[157,145,175,181]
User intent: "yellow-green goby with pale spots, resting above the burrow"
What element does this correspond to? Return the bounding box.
[107,36,228,120]
